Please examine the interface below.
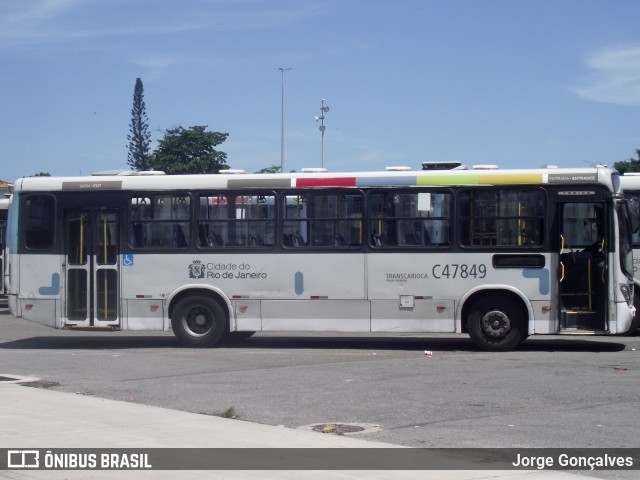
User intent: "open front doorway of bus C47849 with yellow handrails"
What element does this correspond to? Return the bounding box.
[558,202,609,333]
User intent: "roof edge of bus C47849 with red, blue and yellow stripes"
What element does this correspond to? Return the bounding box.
[14,167,618,192]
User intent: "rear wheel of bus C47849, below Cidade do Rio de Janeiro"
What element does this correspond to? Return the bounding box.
[171,295,228,347]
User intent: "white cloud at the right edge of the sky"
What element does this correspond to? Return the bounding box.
[572,45,640,105]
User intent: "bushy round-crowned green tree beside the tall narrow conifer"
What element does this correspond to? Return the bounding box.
[151,125,229,175]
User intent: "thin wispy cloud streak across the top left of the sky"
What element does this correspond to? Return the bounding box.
[0,0,326,47]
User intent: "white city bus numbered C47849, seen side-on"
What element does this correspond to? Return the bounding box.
[7,168,635,351]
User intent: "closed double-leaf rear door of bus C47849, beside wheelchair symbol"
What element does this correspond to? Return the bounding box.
[63,209,120,327]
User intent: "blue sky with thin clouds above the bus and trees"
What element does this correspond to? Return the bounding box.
[0,0,640,180]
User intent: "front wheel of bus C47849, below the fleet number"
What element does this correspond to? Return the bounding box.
[467,295,527,352]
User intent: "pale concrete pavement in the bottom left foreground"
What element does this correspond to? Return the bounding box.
[0,373,608,480]
